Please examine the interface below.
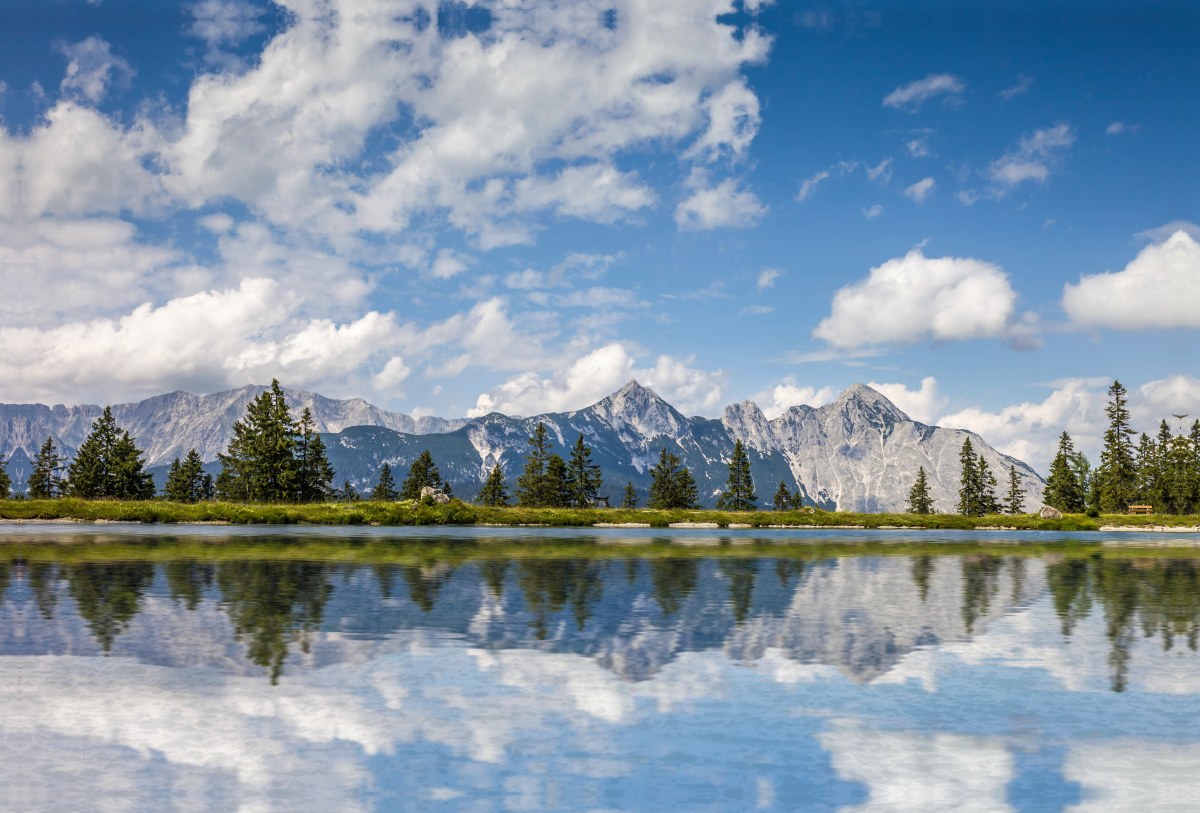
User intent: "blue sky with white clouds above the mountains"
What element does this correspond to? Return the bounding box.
[0,0,1200,471]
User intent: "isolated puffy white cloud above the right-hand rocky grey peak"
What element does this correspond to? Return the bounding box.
[812,248,1033,350]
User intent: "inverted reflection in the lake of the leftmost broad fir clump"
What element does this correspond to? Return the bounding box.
[65,561,154,654]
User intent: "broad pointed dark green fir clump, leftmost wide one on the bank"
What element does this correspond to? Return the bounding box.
[67,407,155,500]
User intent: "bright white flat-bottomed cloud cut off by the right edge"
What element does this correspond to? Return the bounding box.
[1062,229,1200,330]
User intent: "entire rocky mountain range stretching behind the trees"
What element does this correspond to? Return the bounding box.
[0,380,1045,512]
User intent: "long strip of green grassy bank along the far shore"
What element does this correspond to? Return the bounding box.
[0,499,1200,531]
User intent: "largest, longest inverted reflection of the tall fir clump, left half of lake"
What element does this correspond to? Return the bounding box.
[217,561,334,685]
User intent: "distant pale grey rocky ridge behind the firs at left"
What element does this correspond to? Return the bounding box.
[0,385,467,466]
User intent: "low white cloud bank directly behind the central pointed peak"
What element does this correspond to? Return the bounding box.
[467,342,725,417]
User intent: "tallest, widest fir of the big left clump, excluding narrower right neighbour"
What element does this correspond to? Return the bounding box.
[217,379,298,502]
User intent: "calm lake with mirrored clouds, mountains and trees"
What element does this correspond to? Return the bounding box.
[0,524,1200,813]
